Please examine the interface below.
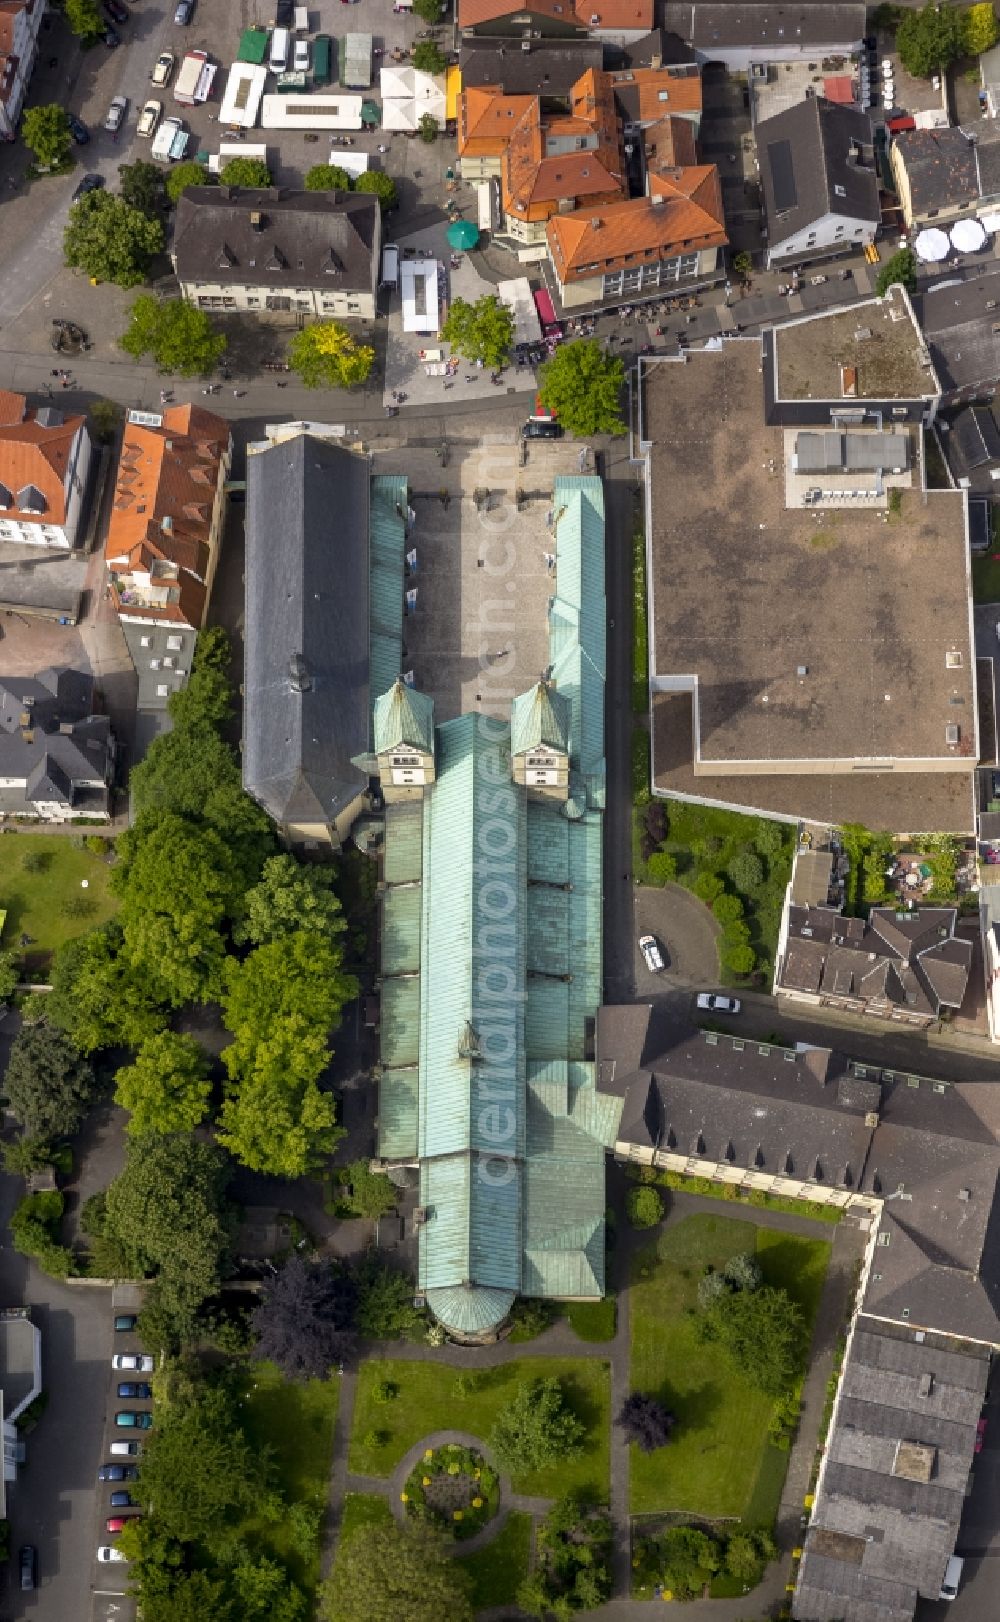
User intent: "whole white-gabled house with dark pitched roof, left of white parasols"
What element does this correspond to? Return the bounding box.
[757,96,882,268]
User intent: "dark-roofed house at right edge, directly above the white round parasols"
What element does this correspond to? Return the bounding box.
[888,125,1000,227]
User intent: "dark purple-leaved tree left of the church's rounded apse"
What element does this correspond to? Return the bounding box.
[251,1255,357,1380]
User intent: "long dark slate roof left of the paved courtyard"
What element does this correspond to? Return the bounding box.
[243,433,370,824]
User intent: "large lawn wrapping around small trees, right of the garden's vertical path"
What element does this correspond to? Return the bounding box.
[630,1215,830,1525]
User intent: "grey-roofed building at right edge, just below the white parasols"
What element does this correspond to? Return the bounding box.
[914,264,1000,406]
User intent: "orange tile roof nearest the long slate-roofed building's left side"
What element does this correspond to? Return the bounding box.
[104,406,230,628]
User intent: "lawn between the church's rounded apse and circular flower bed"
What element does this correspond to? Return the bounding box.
[348,1358,611,1504]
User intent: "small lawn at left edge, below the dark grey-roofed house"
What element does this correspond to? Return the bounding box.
[0,834,118,968]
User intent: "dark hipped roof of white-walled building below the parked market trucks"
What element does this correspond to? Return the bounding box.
[172,187,379,292]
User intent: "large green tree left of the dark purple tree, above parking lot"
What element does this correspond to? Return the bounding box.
[105,1135,230,1324]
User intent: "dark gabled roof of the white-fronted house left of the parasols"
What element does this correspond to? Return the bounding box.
[757,96,880,247]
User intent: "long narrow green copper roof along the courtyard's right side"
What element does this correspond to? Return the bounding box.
[549,477,608,803]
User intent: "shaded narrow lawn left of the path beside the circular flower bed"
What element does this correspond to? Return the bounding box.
[241,1362,340,1594]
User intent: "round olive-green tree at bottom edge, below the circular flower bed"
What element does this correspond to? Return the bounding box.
[319,1523,472,1622]
